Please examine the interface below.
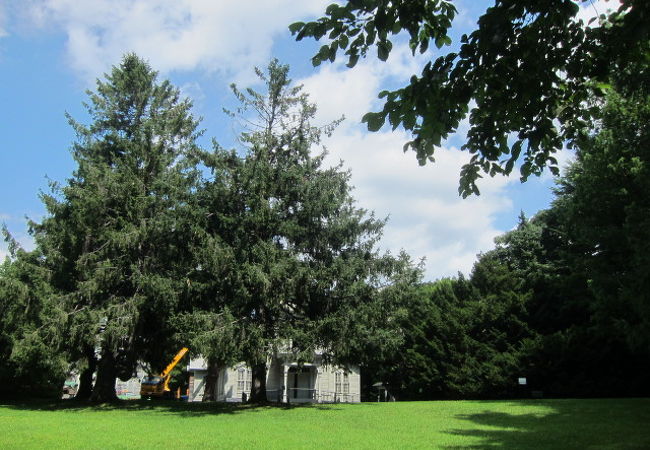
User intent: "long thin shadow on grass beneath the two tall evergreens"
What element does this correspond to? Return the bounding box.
[0,399,354,417]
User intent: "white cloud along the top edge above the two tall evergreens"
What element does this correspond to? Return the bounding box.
[25,0,328,79]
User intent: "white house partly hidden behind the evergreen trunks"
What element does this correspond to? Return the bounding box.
[187,354,361,403]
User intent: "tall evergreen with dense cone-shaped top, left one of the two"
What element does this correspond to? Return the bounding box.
[35,55,197,401]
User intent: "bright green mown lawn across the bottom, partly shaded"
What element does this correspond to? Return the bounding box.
[0,399,650,449]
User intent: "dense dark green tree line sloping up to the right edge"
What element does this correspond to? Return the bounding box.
[364,88,650,399]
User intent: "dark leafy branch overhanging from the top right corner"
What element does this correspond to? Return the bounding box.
[289,0,650,197]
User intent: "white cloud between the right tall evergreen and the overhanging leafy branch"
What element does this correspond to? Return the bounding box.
[301,53,513,279]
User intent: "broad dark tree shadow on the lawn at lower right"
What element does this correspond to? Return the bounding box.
[446,399,650,449]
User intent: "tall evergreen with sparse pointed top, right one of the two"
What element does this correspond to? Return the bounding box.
[195,61,416,401]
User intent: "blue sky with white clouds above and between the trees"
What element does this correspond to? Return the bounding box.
[0,0,613,280]
